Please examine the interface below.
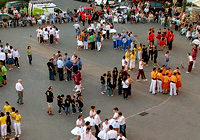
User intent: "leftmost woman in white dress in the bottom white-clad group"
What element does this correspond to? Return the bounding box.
[71,115,83,140]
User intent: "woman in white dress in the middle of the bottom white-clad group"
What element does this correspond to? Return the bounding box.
[98,119,110,140]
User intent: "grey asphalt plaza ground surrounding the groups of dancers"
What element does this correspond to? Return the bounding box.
[0,0,200,140]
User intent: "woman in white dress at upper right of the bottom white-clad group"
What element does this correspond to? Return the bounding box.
[108,107,120,132]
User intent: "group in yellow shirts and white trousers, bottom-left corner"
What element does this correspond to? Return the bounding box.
[0,101,21,140]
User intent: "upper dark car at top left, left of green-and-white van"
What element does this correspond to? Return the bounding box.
[5,1,28,14]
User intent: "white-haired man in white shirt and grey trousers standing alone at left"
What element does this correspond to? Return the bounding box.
[15,79,24,105]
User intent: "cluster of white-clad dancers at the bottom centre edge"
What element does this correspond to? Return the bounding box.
[71,106,126,140]
